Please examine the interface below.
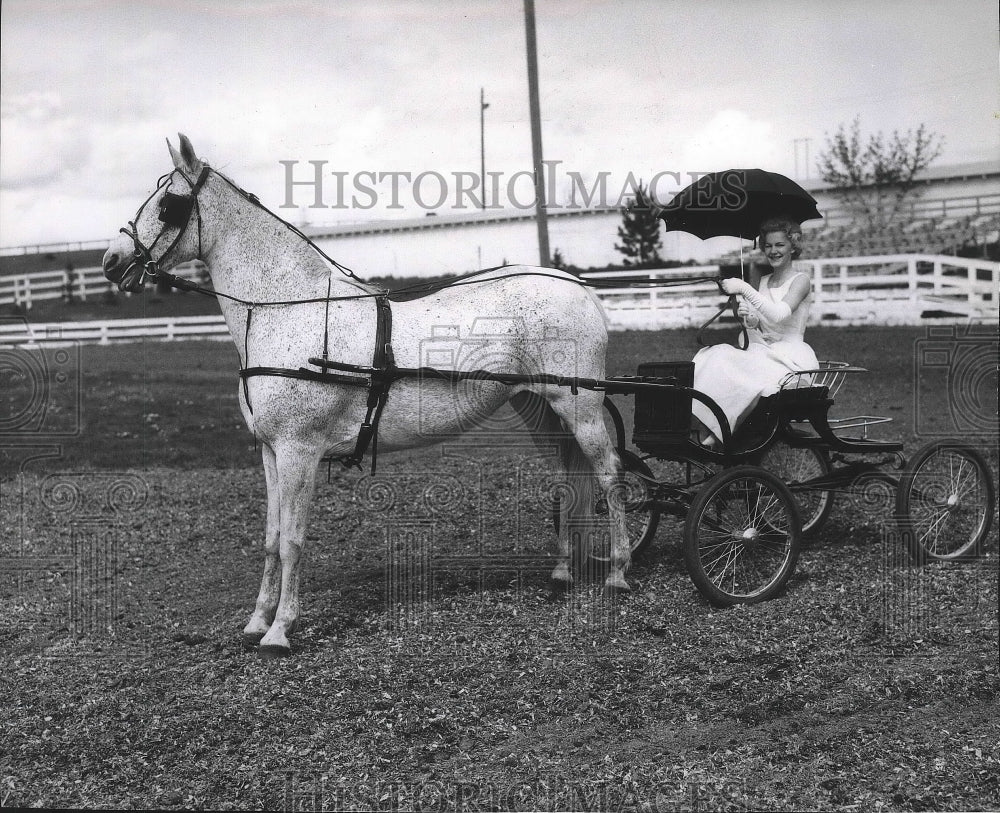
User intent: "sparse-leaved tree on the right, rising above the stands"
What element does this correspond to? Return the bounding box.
[816,118,943,231]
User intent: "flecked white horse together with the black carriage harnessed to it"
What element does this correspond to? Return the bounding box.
[104,137,994,656]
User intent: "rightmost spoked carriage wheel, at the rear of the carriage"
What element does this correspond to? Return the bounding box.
[896,440,996,564]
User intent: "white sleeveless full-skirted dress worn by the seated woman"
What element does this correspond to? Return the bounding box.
[691,271,818,438]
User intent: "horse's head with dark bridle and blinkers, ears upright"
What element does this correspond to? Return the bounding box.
[103,134,210,293]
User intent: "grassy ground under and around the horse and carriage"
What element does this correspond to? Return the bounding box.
[0,328,1000,811]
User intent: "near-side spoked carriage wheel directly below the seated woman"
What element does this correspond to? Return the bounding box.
[684,466,801,606]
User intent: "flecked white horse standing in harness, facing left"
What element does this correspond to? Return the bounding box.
[104,135,630,657]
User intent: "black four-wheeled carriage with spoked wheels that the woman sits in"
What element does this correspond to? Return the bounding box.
[584,361,996,605]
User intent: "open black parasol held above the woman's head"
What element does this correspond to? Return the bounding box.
[658,169,823,240]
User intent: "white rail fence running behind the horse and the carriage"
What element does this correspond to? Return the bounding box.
[0,254,1000,346]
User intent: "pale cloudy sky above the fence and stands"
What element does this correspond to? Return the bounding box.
[0,0,1000,247]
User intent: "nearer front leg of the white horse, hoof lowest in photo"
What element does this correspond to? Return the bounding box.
[258,447,319,659]
